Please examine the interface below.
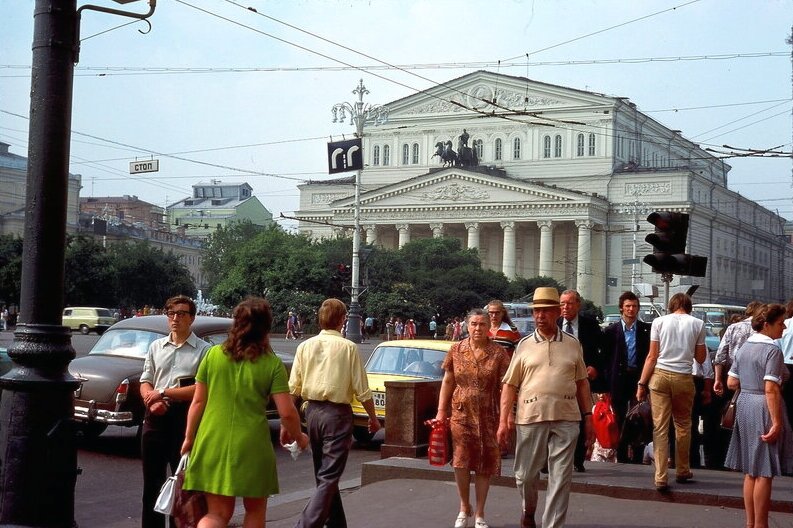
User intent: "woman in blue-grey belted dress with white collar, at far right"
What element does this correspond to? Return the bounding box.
[724,304,793,528]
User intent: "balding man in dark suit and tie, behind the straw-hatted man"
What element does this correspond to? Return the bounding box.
[556,290,608,472]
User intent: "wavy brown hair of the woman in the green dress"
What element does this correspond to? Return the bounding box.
[223,297,273,361]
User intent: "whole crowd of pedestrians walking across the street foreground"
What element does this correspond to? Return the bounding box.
[135,287,793,528]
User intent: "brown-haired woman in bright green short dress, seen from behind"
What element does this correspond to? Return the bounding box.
[182,297,308,528]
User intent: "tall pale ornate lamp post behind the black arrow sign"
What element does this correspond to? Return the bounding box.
[332,79,388,343]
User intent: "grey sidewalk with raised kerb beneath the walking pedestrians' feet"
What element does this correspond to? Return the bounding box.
[249,458,793,528]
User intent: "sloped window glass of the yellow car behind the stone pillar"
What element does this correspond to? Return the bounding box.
[366,346,446,379]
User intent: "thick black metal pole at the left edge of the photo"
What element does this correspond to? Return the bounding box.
[0,0,77,527]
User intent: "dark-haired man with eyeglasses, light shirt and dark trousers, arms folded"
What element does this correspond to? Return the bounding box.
[140,295,209,528]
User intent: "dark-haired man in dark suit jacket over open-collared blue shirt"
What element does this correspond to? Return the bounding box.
[603,291,651,463]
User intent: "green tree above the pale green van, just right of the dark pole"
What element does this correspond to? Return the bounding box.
[64,235,117,306]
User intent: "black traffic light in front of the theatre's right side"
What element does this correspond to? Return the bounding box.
[644,211,708,277]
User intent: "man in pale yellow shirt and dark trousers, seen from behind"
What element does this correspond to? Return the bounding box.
[289,299,380,528]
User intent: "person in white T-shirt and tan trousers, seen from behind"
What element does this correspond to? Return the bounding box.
[636,293,707,492]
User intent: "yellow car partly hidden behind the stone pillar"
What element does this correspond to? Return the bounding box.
[352,339,454,442]
